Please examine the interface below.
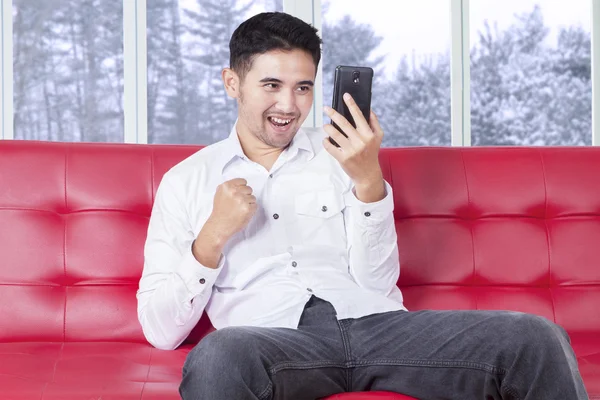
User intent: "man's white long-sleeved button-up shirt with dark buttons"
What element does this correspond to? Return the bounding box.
[137,127,405,349]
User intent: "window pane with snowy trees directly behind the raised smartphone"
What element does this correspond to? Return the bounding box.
[323,0,451,147]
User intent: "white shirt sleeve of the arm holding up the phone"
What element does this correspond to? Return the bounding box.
[344,182,400,296]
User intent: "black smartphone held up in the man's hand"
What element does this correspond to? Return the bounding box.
[329,65,373,147]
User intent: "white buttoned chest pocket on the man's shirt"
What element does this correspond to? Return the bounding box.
[292,188,346,247]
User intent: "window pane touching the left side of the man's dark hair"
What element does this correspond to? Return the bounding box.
[148,0,283,144]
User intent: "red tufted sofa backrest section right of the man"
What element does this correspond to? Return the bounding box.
[380,147,600,335]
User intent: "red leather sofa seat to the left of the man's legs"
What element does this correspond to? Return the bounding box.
[0,342,190,400]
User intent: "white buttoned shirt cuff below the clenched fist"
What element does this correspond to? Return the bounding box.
[175,246,225,302]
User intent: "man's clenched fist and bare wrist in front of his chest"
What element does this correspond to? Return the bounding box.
[192,178,258,268]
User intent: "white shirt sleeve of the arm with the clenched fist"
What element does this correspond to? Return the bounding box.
[137,173,225,349]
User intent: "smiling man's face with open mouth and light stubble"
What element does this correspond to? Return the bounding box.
[231,50,316,148]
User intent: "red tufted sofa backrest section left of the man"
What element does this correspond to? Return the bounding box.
[0,141,198,342]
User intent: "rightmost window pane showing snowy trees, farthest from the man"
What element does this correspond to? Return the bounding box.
[471,0,592,145]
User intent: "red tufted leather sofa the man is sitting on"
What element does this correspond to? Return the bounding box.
[0,141,600,400]
